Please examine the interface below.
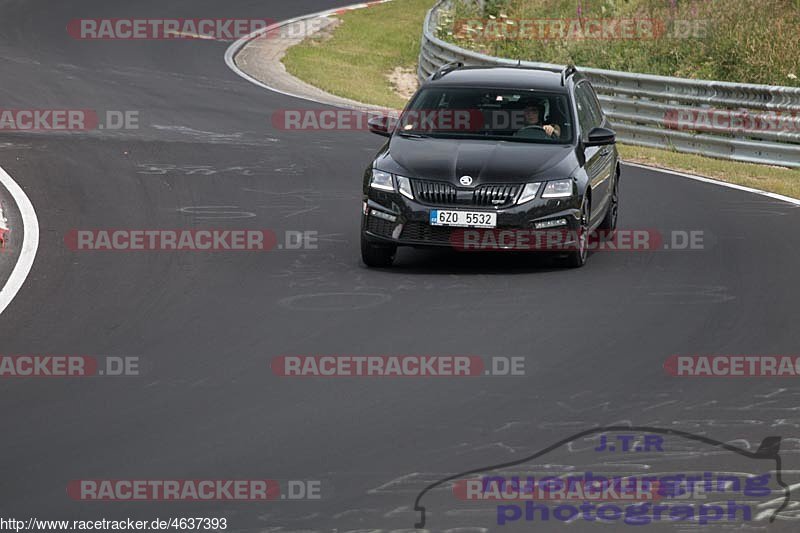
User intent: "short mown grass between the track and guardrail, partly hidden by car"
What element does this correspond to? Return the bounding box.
[284,0,800,198]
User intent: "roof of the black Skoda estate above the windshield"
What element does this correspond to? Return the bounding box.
[425,67,567,92]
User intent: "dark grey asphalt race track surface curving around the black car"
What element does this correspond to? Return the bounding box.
[0,0,800,532]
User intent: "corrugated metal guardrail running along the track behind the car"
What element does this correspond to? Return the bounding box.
[417,0,800,168]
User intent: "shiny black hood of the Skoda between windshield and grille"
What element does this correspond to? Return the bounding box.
[375,135,578,185]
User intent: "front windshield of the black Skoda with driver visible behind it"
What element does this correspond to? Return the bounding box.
[395,87,573,144]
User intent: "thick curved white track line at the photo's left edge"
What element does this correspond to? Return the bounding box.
[0,167,39,314]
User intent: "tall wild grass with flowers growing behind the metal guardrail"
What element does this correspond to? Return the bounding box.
[439,0,800,87]
